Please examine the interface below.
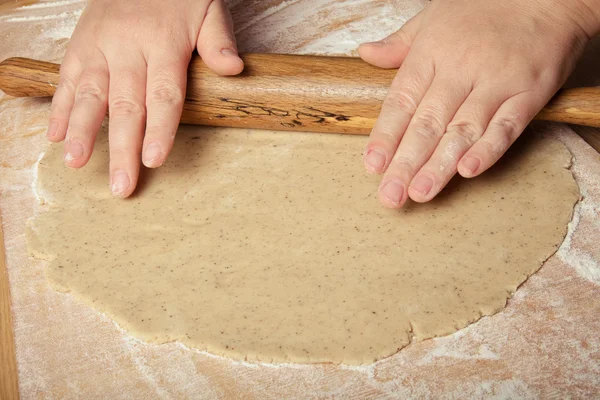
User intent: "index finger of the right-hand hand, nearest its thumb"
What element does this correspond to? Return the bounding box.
[363,56,434,173]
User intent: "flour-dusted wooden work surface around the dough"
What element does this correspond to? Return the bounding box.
[0,0,600,398]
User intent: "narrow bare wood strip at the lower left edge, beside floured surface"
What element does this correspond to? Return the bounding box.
[0,220,19,400]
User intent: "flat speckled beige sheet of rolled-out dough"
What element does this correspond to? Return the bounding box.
[28,127,579,364]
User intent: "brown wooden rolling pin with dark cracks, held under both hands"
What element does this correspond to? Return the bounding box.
[0,54,600,135]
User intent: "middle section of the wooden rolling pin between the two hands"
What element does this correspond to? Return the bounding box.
[182,54,395,134]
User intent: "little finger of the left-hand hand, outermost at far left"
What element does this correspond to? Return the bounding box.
[46,55,81,142]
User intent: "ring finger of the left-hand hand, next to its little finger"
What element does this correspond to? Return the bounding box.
[64,53,108,168]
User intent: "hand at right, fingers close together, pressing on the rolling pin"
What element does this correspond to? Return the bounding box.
[358,0,600,208]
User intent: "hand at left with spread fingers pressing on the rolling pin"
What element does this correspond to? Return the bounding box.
[47,0,244,197]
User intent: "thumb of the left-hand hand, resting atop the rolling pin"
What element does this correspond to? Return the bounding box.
[197,0,244,75]
